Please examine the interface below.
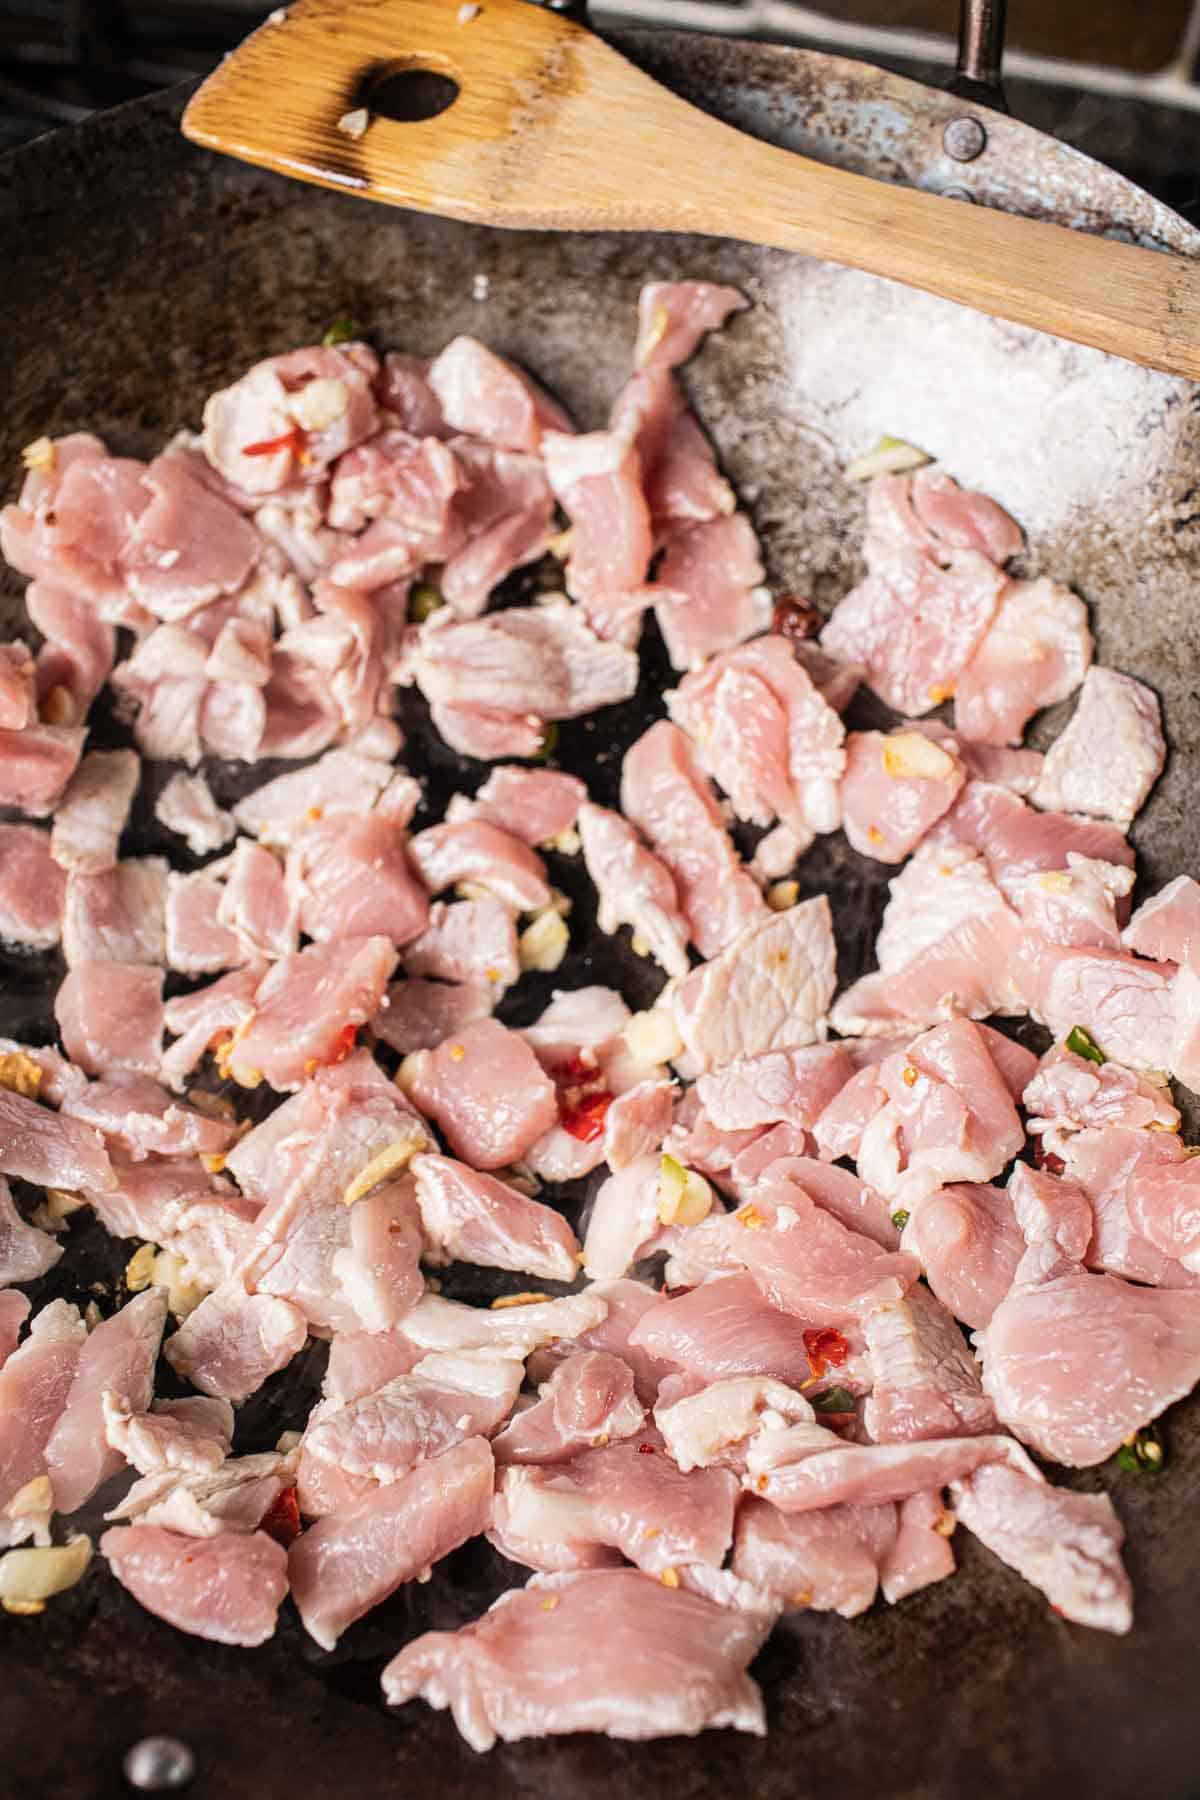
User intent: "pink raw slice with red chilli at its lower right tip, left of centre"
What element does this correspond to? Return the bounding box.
[228,938,396,1091]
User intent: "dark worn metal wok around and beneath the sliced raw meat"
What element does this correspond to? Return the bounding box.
[0,10,1200,1800]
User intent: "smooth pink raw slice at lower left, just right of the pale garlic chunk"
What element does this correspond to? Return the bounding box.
[101,1525,288,1645]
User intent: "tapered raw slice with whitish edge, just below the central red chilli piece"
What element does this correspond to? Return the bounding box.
[412,1156,579,1282]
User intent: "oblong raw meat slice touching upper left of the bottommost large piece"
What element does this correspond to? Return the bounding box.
[288,1438,493,1651]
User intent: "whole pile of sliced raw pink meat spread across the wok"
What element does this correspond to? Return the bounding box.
[0,283,1200,1750]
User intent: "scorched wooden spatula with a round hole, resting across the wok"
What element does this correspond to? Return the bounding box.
[184,0,1200,380]
